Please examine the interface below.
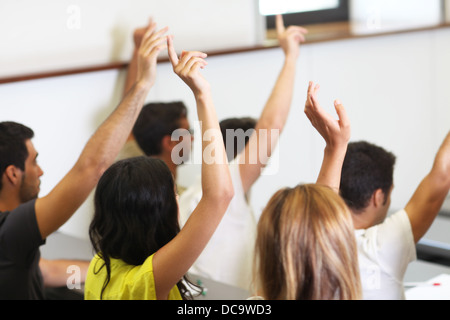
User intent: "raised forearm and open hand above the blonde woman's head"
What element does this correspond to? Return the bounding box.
[305,82,351,192]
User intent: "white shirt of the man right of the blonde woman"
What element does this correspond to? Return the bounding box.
[355,210,417,300]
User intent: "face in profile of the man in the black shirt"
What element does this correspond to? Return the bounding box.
[19,140,44,203]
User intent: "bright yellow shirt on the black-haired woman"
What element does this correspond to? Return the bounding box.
[84,255,182,300]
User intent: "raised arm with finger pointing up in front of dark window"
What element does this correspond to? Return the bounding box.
[240,15,307,192]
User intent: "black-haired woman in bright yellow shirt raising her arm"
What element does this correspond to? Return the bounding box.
[85,37,233,300]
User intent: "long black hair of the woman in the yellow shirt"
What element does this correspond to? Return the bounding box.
[89,156,198,299]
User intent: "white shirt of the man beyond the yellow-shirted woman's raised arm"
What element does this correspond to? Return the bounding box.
[179,155,256,290]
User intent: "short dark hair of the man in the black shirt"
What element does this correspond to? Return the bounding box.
[0,121,34,190]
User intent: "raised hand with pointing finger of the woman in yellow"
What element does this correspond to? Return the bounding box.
[167,37,210,95]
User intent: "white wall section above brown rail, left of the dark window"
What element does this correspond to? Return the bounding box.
[0,0,263,77]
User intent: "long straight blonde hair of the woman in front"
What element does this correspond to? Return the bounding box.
[254,185,361,300]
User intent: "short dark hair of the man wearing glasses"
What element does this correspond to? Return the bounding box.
[133,101,187,156]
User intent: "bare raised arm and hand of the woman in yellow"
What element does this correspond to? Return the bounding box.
[153,37,233,299]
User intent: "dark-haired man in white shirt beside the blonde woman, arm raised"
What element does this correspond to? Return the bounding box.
[341,133,450,300]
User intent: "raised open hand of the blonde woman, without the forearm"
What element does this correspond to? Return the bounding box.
[305,82,351,148]
